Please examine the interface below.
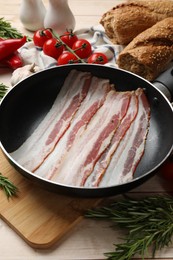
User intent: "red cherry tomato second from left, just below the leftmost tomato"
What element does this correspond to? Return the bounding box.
[43,38,64,59]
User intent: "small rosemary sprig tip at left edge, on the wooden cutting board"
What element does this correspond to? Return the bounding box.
[0,173,18,199]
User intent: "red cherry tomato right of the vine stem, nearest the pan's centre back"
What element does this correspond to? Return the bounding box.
[72,39,92,59]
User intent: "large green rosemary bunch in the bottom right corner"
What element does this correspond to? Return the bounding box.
[86,196,173,260]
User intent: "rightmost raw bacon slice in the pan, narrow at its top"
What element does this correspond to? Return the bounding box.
[100,89,150,187]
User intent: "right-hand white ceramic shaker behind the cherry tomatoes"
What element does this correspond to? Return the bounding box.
[44,0,76,35]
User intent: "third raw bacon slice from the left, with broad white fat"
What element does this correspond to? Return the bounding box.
[52,90,131,186]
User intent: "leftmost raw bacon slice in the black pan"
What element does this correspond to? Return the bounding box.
[11,71,91,171]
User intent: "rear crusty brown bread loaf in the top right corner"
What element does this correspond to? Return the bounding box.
[100,0,173,45]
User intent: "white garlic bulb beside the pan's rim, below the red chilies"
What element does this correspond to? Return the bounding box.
[11,63,41,86]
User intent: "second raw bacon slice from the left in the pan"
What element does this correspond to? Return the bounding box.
[35,77,112,179]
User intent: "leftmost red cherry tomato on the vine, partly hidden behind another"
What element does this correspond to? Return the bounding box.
[33,29,53,48]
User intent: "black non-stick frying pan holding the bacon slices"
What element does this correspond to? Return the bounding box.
[0,64,173,197]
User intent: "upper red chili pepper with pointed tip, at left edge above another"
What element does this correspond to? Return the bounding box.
[0,36,26,61]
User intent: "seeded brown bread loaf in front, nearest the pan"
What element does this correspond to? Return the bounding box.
[117,17,173,81]
